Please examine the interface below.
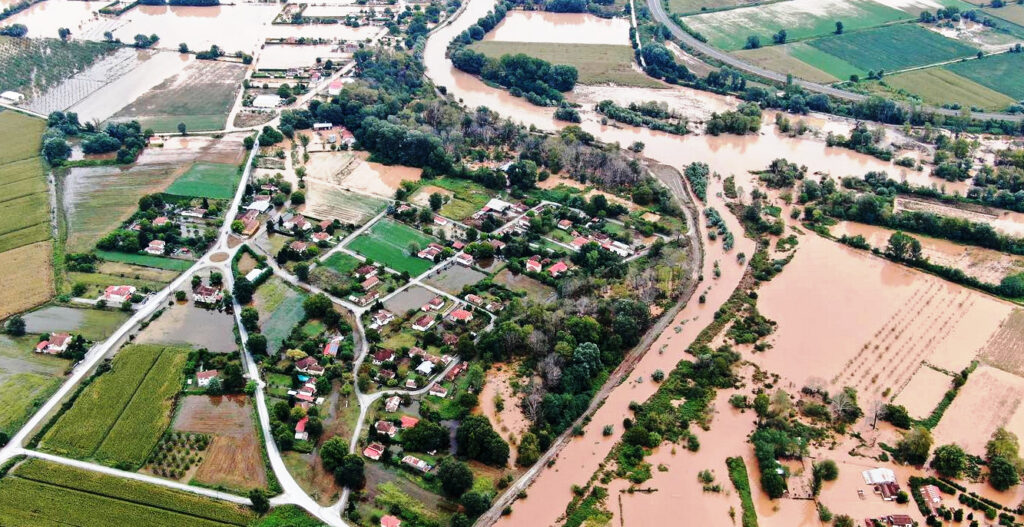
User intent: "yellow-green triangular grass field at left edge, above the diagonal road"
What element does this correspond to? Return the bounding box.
[0,335,69,435]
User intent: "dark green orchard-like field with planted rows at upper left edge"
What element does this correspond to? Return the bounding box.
[0,37,116,98]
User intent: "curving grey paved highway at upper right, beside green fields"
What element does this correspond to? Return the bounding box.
[647,0,1024,122]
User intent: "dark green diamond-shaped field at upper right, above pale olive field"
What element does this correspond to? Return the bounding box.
[808,24,978,72]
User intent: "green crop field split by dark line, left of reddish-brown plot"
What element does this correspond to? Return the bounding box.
[40,345,187,468]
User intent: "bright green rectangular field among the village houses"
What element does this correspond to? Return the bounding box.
[348,219,434,276]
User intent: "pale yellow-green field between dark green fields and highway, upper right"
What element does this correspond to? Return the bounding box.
[885,68,1015,112]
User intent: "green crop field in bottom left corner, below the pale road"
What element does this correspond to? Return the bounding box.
[0,459,254,527]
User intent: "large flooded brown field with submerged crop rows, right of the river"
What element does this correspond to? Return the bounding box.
[753,235,1012,401]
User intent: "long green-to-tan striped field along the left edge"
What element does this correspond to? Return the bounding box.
[0,111,53,318]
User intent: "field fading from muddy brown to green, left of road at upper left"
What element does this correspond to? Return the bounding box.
[111,60,246,132]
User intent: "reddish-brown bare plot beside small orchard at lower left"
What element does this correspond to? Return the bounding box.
[173,395,266,489]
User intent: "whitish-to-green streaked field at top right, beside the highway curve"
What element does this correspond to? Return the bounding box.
[684,0,911,50]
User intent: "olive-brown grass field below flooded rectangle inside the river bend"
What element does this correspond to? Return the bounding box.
[470,40,664,88]
